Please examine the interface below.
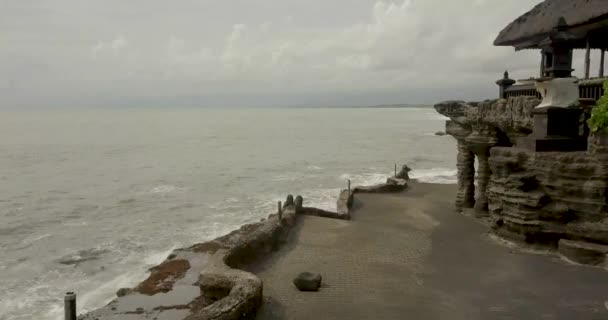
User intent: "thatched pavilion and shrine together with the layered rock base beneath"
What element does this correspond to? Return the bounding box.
[435,0,608,264]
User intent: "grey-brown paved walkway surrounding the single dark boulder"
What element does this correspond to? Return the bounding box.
[251,184,608,320]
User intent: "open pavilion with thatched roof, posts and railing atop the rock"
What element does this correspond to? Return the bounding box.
[494,0,608,99]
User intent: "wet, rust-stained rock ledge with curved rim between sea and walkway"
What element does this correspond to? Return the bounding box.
[78,198,296,320]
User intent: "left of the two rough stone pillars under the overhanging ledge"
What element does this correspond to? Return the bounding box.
[456,139,475,210]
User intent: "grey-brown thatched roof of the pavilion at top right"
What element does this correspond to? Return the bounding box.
[494,0,608,49]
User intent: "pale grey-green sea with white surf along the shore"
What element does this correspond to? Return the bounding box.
[0,108,456,320]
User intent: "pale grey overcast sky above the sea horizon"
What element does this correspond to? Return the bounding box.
[0,0,600,108]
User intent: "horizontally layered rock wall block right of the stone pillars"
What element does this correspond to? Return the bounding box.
[488,147,608,245]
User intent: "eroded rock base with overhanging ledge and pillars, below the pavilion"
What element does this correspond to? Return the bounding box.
[435,97,608,250]
